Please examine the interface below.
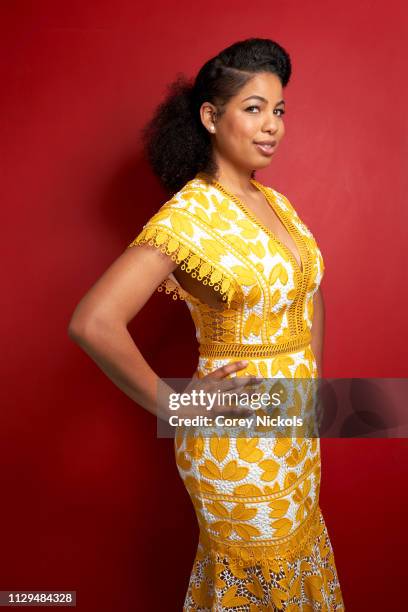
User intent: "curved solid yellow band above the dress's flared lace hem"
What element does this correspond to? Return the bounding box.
[199,503,324,566]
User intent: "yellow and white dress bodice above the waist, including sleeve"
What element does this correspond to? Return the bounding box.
[129,173,324,366]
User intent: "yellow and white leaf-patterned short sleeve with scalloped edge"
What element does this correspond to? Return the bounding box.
[127,196,241,308]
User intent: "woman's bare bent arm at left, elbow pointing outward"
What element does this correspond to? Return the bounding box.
[68,245,178,416]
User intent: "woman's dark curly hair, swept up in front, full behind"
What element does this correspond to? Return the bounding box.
[142,38,292,194]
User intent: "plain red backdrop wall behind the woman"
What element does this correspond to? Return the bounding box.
[0,0,408,612]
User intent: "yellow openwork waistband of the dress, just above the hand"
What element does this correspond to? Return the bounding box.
[198,330,312,359]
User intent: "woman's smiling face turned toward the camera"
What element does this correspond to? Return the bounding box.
[207,72,285,173]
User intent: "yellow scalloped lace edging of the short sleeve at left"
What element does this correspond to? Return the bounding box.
[127,226,241,308]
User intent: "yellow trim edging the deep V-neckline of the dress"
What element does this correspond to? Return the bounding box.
[203,177,306,276]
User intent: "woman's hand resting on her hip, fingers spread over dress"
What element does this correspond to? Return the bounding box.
[174,361,263,417]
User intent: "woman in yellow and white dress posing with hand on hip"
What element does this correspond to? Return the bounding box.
[69,38,345,612]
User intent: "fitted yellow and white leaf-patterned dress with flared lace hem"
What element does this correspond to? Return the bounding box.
[129,173,345,612]
